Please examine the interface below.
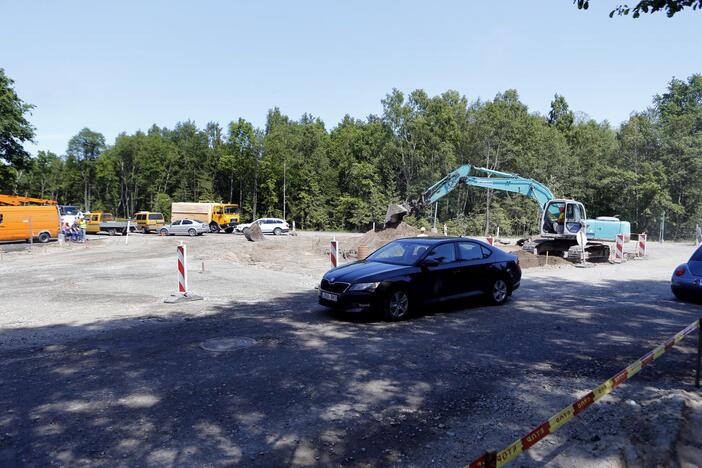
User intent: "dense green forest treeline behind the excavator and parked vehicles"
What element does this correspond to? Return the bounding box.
[1,75,702,238]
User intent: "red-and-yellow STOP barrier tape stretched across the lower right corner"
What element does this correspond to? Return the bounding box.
[466,320,701,468]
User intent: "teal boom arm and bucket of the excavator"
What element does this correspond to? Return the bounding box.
[385,164,555,226]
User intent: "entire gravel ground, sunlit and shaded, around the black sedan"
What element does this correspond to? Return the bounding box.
[0,233,702,467]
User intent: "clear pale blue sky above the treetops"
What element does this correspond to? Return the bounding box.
[0,0,702,154]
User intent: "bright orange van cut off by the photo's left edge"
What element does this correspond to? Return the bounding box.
[0,195,60,243]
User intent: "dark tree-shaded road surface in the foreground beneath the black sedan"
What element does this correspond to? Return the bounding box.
[0,239,702,467]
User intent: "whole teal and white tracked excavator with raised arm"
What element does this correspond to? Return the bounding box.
[385,164,631,260]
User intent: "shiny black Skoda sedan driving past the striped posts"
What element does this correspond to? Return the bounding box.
[319,237,522,320]
